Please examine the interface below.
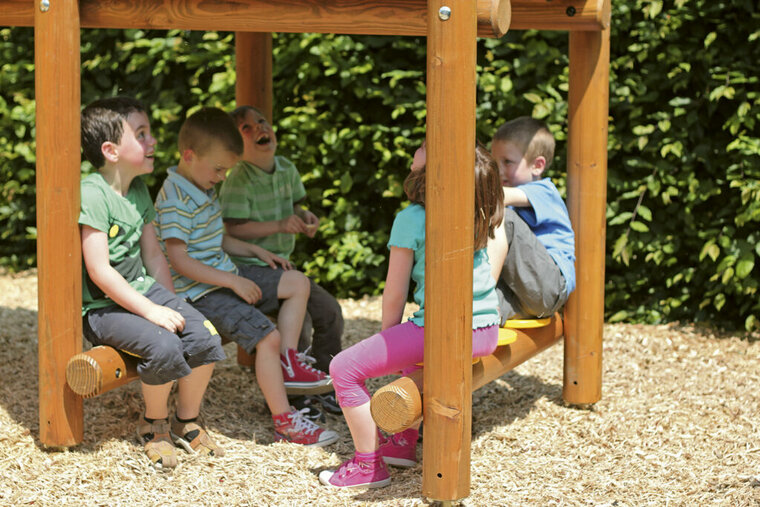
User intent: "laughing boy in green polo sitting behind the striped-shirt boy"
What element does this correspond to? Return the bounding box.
[219,106,343,413]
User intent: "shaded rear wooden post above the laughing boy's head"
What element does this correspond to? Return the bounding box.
[235,32,273,122]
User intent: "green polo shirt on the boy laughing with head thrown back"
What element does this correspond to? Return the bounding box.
[219,156,306,266]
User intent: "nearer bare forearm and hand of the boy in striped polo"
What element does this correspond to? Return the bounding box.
[165,238,261,305]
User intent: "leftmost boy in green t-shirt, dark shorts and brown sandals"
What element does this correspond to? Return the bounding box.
[79,97,224,469]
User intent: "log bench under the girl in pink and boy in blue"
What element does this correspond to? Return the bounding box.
[370,315,563,433]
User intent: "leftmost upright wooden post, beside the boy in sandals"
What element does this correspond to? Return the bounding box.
[34,0,83,447]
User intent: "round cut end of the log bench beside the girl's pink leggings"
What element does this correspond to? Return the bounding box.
[370,377,422,433]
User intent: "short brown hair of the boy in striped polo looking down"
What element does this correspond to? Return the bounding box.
[177,107,243,155]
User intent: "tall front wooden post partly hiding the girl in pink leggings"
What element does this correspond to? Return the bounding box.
[422,0,477,501]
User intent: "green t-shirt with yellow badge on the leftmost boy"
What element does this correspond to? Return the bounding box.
[79,173,156,315]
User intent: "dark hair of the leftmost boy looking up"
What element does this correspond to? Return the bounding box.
[82,97,147,169]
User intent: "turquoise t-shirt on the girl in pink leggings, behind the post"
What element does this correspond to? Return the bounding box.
[388,204,499,329]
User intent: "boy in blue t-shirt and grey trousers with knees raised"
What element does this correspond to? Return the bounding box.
[488,116,575,324]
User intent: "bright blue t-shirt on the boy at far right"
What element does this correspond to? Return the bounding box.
[514,178,575,294]
